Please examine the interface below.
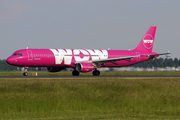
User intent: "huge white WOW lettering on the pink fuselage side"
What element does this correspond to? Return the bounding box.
[50,49,108,65]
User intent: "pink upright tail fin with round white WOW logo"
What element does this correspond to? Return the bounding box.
[134,26,156,52]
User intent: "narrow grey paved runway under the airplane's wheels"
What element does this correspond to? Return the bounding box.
[0,75,180,79]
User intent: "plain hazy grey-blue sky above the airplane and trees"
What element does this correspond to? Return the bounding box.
[0,0,180,59]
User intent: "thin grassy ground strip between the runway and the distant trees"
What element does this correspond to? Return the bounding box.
[0,71,180,77]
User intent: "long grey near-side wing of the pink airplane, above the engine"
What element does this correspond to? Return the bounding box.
[75,55,140,66]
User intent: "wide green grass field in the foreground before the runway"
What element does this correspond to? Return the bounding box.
[0,78,180,120]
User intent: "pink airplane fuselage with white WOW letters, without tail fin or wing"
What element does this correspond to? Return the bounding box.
[7,49,158,68]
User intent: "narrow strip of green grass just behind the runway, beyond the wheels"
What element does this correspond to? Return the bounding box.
[0,71,180,76]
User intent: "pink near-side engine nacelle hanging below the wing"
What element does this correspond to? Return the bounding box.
[76,62,94,72]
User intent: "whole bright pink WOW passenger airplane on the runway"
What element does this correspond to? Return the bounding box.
[6,26,170,76]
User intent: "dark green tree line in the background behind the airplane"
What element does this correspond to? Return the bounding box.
[0,58,180,71]
